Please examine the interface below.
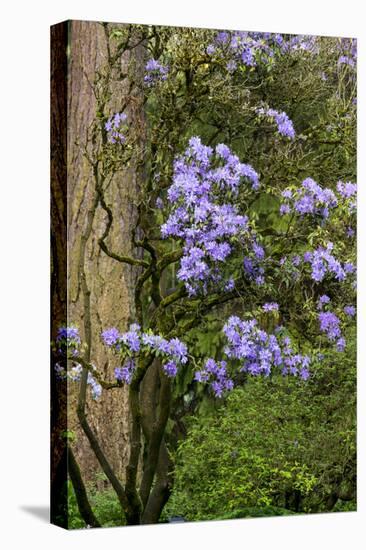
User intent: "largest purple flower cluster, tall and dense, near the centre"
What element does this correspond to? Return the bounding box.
[161,137,264,295]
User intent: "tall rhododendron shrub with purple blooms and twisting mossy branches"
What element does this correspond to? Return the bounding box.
[54,22,357,524]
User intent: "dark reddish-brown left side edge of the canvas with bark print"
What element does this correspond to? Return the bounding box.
[50,23,67,526]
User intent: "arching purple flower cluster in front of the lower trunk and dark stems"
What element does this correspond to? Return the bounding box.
[102,324,188,384]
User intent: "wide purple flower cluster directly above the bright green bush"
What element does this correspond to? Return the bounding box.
[224,316,310,380]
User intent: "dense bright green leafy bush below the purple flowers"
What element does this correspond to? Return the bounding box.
[164,345,356,520]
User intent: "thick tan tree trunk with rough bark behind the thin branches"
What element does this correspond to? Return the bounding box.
[68,21,140,486]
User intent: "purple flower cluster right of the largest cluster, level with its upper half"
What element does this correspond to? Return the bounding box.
[280,178,338,219]
